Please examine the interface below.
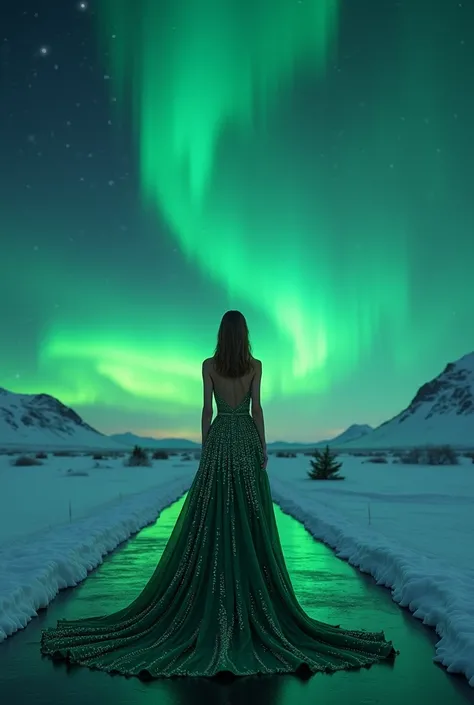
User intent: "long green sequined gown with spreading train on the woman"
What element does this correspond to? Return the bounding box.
[41,393,394,678]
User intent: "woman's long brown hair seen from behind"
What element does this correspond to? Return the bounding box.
[213,311,252,377]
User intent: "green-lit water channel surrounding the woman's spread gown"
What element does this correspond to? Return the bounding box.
[0,496,474,705]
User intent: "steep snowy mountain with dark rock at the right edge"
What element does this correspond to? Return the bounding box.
[348,352,474,448]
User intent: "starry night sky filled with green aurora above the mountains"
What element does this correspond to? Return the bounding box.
[0,0,474,441]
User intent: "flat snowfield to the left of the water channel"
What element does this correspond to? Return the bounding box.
[0,456,197,642]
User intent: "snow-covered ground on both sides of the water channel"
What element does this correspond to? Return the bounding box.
[0,456,474,687]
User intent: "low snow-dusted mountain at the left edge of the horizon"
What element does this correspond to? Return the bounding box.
[0,388,121,450]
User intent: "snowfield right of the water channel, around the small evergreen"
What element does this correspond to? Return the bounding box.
[270,457,474,687]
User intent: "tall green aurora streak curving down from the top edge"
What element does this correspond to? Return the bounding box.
[96,0,407,393]
